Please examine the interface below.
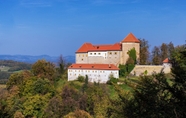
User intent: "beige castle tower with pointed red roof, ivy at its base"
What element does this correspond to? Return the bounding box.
[120,33,140,64]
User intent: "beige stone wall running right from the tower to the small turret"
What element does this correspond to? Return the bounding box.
[131,65,171,76]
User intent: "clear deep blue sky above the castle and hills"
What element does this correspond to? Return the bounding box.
[0,0,186,56]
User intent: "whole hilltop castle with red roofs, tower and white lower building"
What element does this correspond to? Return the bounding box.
[68,33,140,83]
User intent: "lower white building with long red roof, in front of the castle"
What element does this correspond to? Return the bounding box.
[68,64,119,83]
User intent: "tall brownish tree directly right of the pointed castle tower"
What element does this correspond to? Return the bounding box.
[139,39,150,65]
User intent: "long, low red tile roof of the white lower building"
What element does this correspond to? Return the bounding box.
[68,64,119,70]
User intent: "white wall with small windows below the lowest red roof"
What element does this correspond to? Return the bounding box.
[68,69,119,83]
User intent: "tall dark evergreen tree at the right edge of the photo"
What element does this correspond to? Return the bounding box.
[170,45,186,118]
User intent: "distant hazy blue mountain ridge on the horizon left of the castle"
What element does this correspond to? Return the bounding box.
[0,55,75,63]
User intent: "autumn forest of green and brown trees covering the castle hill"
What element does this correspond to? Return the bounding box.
[0,40,186,118]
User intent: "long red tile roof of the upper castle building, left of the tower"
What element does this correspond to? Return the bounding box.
[76,43,121,53]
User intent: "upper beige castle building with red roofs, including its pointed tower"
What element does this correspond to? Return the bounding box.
[76,33,140,66]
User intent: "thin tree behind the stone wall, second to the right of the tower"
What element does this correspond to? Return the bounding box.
[152,46,161,65]
